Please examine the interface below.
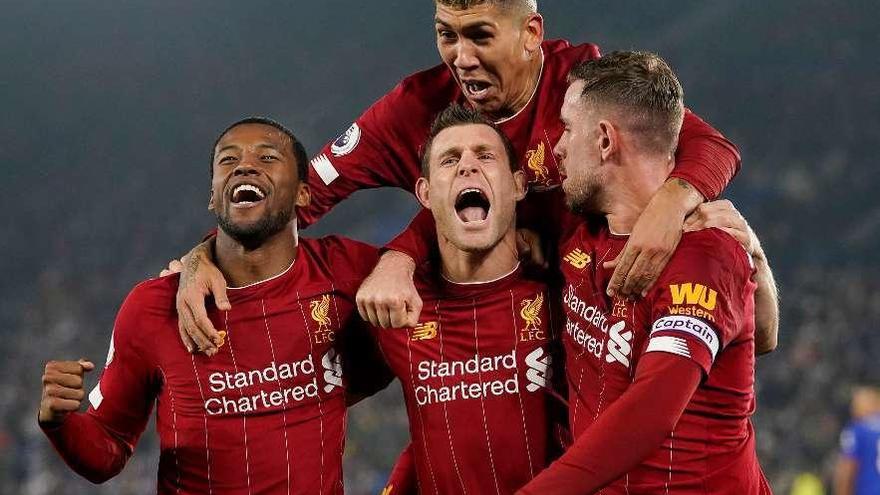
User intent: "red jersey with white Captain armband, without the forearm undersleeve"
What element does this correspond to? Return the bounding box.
[561,223,769,495]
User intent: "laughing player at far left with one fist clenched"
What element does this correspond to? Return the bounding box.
[39,118,387,494]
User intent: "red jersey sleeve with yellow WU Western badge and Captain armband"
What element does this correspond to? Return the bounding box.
[645,229,754,375]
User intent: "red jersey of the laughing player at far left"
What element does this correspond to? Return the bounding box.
[47,237,384,495]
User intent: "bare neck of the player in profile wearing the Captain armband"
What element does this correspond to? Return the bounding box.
[605,155,673,234]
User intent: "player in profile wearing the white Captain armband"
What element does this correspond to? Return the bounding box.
[518,52,775,495]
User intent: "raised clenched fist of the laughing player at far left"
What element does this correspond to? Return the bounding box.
[39,359,95,424]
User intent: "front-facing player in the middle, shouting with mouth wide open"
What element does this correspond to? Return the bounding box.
[362,105,561,495]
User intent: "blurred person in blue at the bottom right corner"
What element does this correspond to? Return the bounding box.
[834,385,880,495]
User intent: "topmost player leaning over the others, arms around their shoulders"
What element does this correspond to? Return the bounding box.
[172,0,739,353]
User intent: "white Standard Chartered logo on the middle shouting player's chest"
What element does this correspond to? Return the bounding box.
[414,348,551,406]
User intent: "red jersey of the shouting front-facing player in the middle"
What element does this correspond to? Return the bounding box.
[375,269,559,495]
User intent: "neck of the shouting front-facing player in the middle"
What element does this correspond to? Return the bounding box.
[437,229,519,284]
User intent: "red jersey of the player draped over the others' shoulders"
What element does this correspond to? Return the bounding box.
[298,40,739,232]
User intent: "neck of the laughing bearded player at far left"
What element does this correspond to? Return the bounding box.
[216,226,297,287]
